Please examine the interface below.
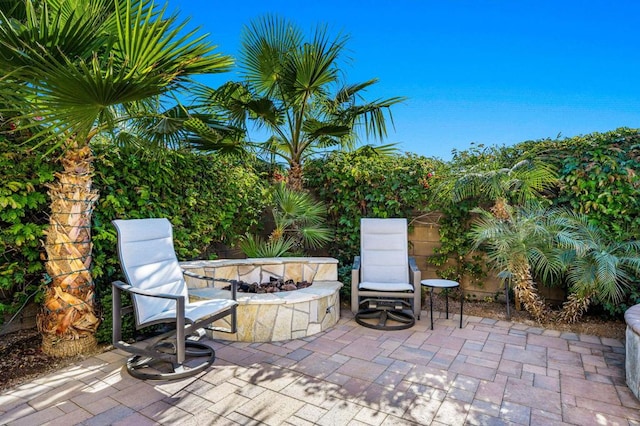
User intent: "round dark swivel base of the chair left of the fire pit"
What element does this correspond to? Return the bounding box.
[127,340,216,380]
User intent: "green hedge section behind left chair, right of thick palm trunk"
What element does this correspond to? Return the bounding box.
[92,146,264,281]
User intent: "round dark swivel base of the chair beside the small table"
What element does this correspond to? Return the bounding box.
[355,299,416,330]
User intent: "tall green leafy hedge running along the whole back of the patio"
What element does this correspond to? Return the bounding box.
[0,128,640,330]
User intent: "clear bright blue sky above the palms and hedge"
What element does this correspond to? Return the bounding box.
[169,0,640,160]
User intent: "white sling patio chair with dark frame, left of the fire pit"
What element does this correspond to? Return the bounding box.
[112,219,237,380]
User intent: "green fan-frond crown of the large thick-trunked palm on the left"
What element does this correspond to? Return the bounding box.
[0,0,231,146]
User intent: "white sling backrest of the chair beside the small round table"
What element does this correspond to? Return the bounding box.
[360,218,409,283]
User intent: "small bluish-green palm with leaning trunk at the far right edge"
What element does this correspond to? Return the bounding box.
[559,215,640,323]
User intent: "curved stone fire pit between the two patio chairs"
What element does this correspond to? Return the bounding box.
[180,257,342,342]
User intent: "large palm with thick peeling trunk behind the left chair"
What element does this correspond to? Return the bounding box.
[0,0,231,356]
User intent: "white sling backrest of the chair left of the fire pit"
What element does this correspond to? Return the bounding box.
[112,219,189,324]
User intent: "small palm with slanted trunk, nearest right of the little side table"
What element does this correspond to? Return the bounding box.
[469,204,576,321]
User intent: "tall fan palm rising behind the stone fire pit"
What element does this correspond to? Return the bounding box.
[190,17,403,189]
